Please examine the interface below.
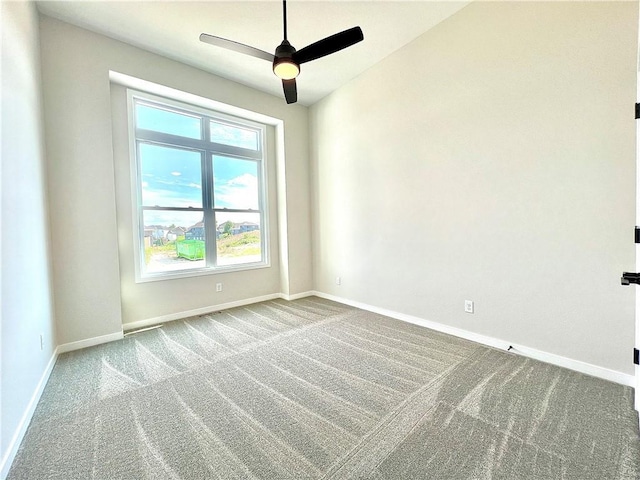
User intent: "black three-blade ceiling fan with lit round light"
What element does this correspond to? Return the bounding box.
[200,0,364,103]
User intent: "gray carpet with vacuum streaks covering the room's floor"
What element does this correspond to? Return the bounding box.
[8,297,640,480]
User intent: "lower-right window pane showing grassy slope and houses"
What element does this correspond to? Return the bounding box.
[216,213,262,265]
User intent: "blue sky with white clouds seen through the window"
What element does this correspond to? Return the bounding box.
[136,101,259,228]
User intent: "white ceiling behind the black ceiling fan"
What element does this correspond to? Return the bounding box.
[37,0,469,105]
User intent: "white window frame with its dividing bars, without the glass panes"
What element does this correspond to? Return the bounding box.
[127,88,271,283]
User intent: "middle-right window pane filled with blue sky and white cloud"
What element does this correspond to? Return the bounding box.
[213,156,260,210]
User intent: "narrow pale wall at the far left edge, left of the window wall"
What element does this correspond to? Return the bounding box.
[0,2,57,468]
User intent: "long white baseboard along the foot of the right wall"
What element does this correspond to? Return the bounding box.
[311,291,636,387]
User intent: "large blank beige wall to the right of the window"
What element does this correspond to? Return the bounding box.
[310,2,638,374]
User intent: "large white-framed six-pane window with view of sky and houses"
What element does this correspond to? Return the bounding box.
[129,90,268,280]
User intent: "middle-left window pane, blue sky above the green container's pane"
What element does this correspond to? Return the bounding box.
[139,143,202,208]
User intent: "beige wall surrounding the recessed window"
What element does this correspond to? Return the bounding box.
[41,17,312,344]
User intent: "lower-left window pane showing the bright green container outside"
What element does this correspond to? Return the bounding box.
[143,210,205,273]
